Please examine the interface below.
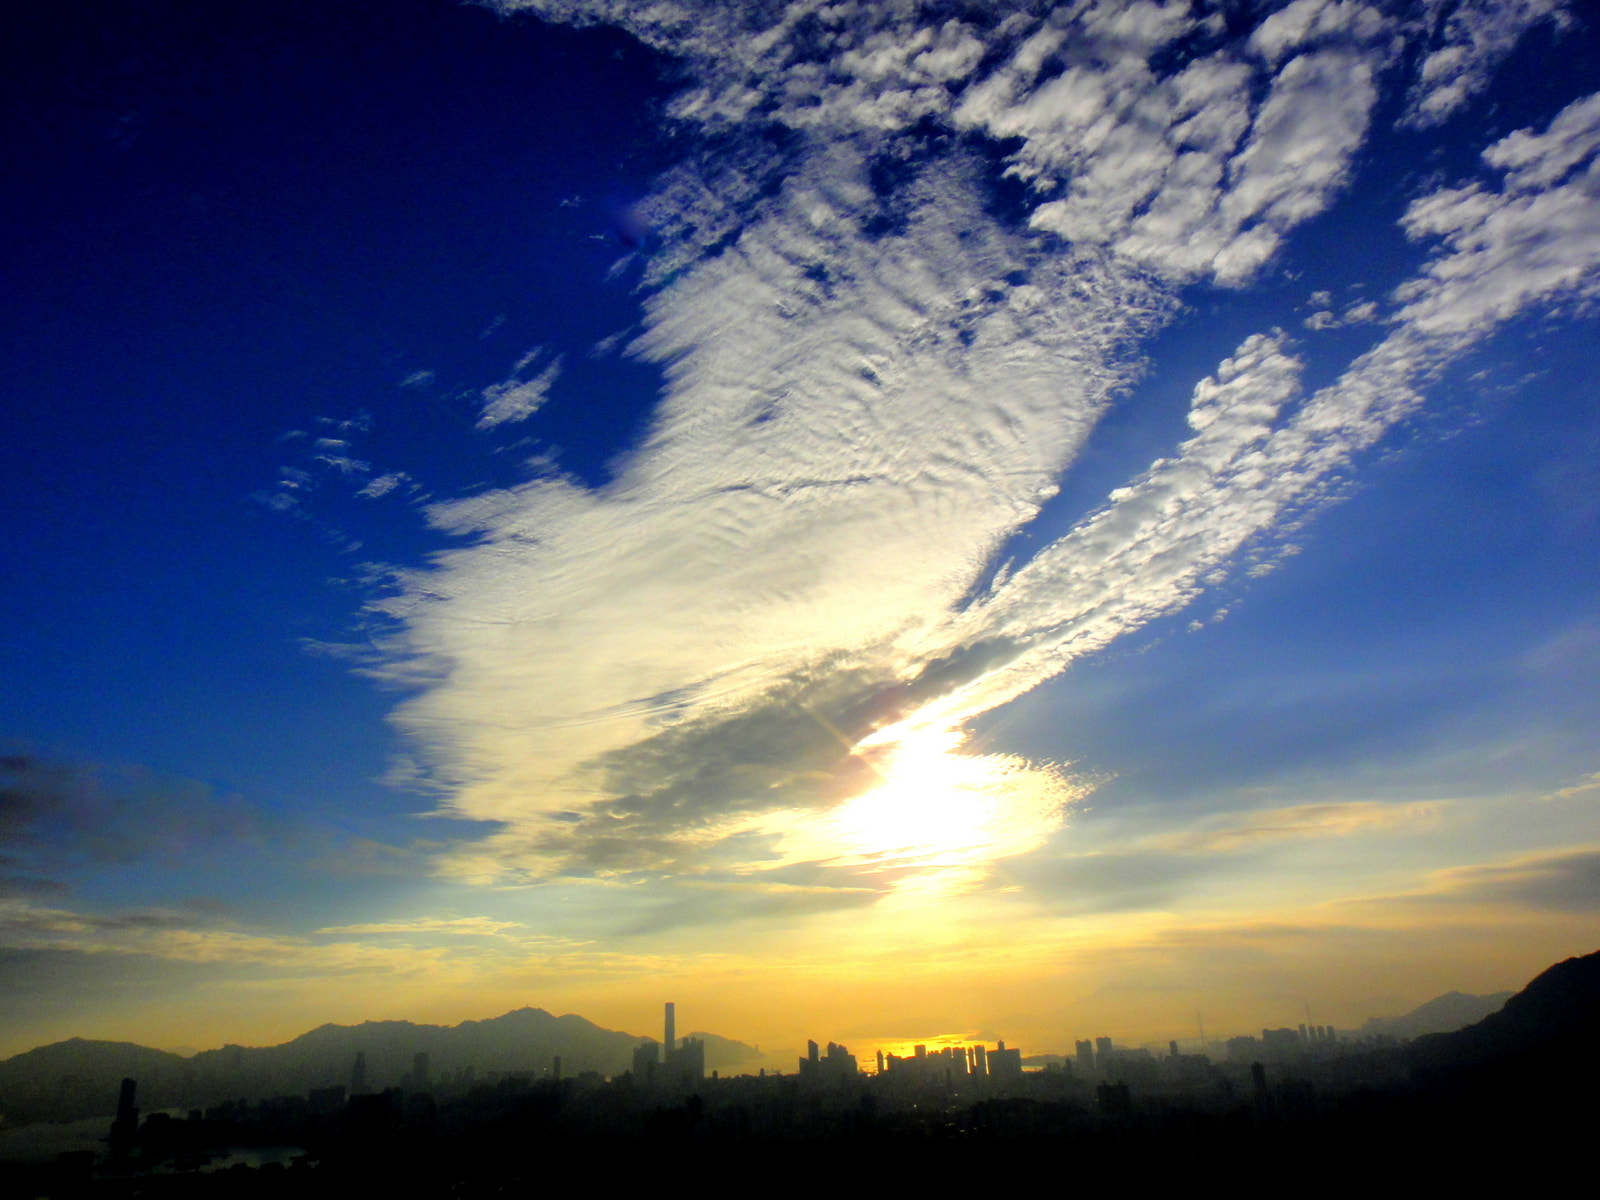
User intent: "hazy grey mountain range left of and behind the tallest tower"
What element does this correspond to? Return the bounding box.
[0,1008,760,1125]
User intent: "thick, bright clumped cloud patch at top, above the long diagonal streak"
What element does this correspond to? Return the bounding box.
[955,0,1387,283]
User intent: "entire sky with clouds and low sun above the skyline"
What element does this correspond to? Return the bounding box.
[0,0,1600,1053]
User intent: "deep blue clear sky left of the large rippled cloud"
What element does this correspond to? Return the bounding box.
[0,0,667,816]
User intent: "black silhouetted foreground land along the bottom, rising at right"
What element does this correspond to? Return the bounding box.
[0,955,1600,1197]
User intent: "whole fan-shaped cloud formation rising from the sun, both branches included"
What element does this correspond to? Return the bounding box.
[334,0,1600,921]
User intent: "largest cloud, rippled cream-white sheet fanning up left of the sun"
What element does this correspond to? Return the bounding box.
[376,150,1158,883]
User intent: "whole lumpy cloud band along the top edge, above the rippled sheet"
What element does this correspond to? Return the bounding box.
[499,0,1395,285]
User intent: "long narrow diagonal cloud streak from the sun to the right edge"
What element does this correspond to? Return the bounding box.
[915,84,1600,732]
